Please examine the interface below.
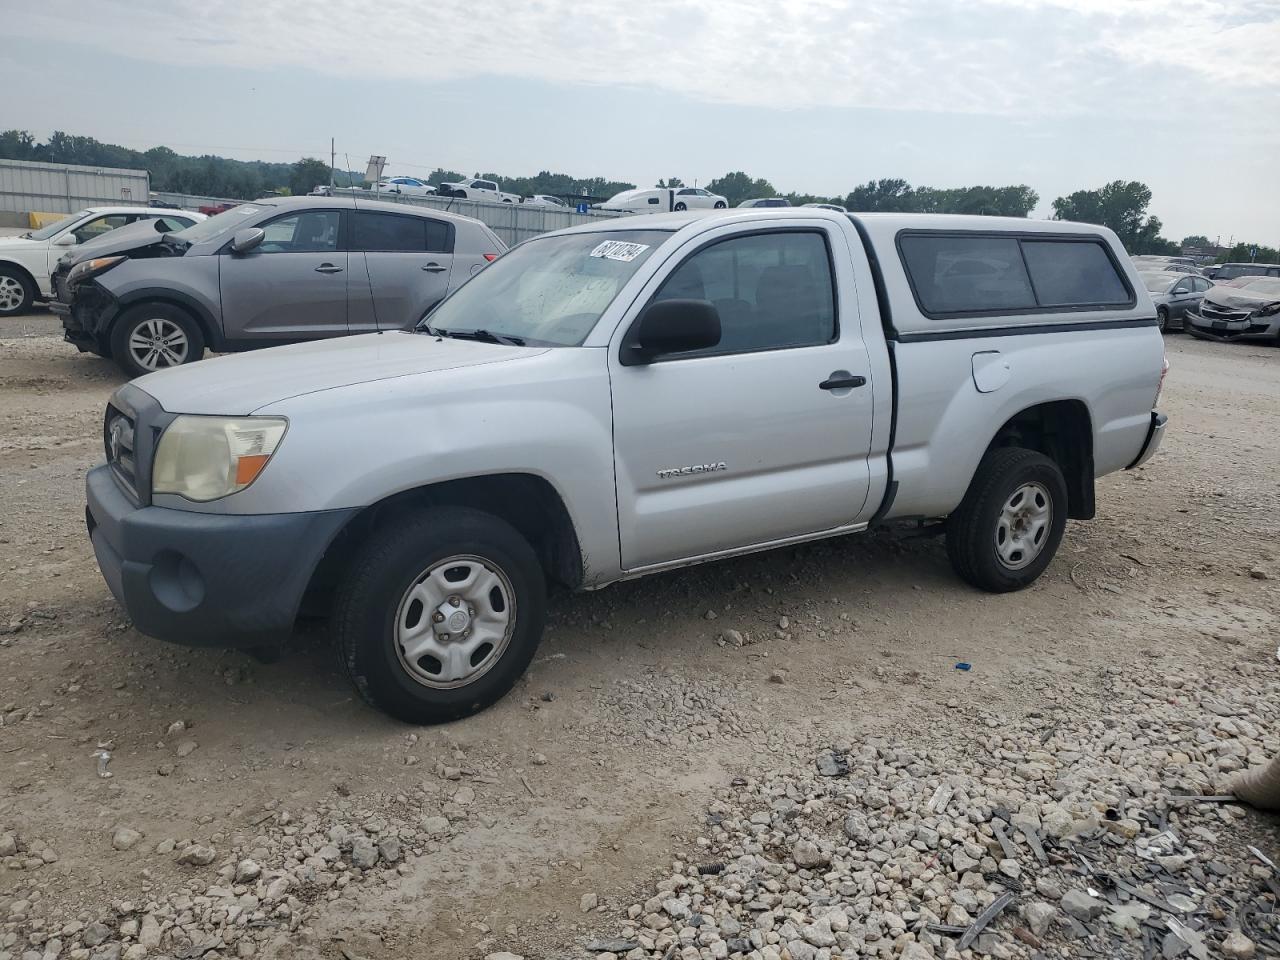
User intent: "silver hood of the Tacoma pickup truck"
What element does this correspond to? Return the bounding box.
[134,330,547,416]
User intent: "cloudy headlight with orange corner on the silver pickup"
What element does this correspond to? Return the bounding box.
[151,416,288,502]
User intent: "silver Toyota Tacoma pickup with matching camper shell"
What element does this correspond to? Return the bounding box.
[87,209,1167,722]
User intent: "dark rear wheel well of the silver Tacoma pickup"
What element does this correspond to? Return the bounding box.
[987,401,1094,520]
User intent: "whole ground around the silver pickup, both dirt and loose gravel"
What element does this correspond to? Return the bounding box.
[0,323,1280,960]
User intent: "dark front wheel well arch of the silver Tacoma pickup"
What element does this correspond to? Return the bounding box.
[303,474,582,613]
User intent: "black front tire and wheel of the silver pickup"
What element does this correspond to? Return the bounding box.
[333,507,547,723]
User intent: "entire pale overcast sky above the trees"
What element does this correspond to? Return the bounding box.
[0,0,1280,246]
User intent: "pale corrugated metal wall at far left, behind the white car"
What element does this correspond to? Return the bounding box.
[0,160,151,214]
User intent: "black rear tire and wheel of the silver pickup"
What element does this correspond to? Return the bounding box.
[947,447,1066,593]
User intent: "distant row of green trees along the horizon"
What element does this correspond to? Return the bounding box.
[0,129,1259,262]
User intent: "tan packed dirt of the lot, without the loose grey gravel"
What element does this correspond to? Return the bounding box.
[0,314,1280,960]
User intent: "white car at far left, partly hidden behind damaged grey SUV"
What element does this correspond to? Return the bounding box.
[0,206,209,316]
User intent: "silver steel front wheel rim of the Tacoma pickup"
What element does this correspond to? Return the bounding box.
[393,554,516,690]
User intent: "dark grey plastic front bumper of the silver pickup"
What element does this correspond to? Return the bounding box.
[86,466,356,646]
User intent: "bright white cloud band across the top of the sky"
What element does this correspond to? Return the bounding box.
[5,0,1280,115]
